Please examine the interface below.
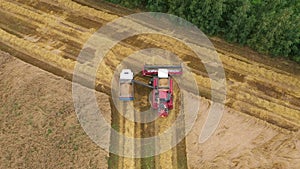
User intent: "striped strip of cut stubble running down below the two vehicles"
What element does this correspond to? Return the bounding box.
[110,79,187,169]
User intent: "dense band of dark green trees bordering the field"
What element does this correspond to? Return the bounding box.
[107,0,300,63]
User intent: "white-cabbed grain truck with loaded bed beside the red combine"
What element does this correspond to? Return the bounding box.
[119,69,134,101]
